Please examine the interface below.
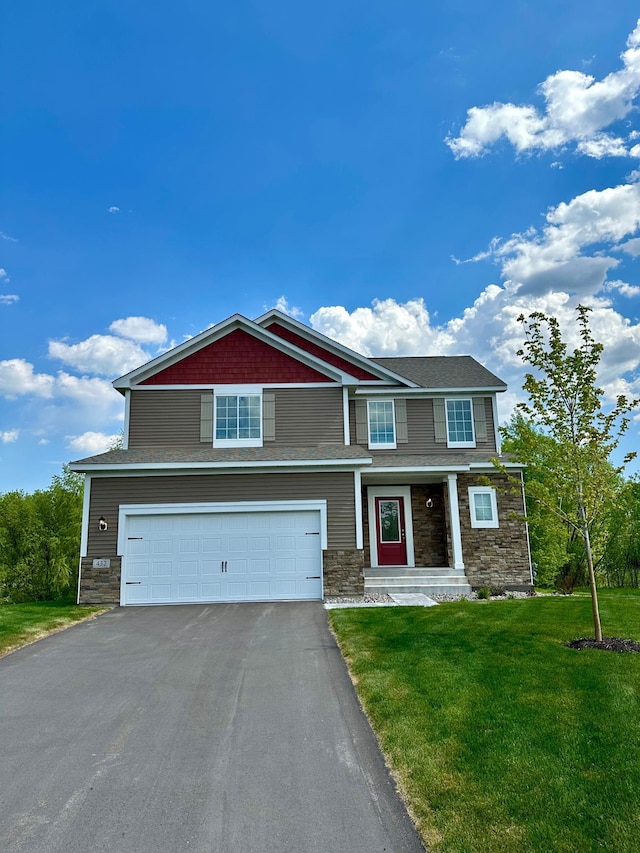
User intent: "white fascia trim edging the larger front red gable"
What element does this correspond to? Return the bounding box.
[113,314,357,390]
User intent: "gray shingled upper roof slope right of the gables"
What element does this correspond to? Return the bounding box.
[371,355,507,391]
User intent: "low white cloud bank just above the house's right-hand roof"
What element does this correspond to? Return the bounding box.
[311,294,640,420]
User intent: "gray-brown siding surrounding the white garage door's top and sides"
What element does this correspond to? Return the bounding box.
[87,471,355,557]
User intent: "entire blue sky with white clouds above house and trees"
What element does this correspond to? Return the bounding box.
[0,0,640,491]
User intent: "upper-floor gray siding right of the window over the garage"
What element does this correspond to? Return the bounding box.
[275,388,344,447]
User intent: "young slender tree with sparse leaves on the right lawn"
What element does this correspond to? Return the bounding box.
[518,305,640,642]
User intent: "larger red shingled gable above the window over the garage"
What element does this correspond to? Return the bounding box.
[140,329,333,385]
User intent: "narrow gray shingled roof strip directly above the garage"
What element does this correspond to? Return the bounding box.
[71,444,371,470]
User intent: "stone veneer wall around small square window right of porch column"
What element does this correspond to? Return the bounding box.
[458,474,532,589]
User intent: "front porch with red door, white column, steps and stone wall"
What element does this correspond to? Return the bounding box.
[361,469,532,596]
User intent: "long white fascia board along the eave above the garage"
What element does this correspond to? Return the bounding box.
[69,457,373,476]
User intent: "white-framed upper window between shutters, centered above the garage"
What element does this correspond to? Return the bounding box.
[213,388,262,447]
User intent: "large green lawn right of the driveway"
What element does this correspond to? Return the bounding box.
[330,590,640,853]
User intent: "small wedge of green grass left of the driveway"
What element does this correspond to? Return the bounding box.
[0,601,105,657]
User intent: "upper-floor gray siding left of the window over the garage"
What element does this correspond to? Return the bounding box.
[129,388,202,448]
